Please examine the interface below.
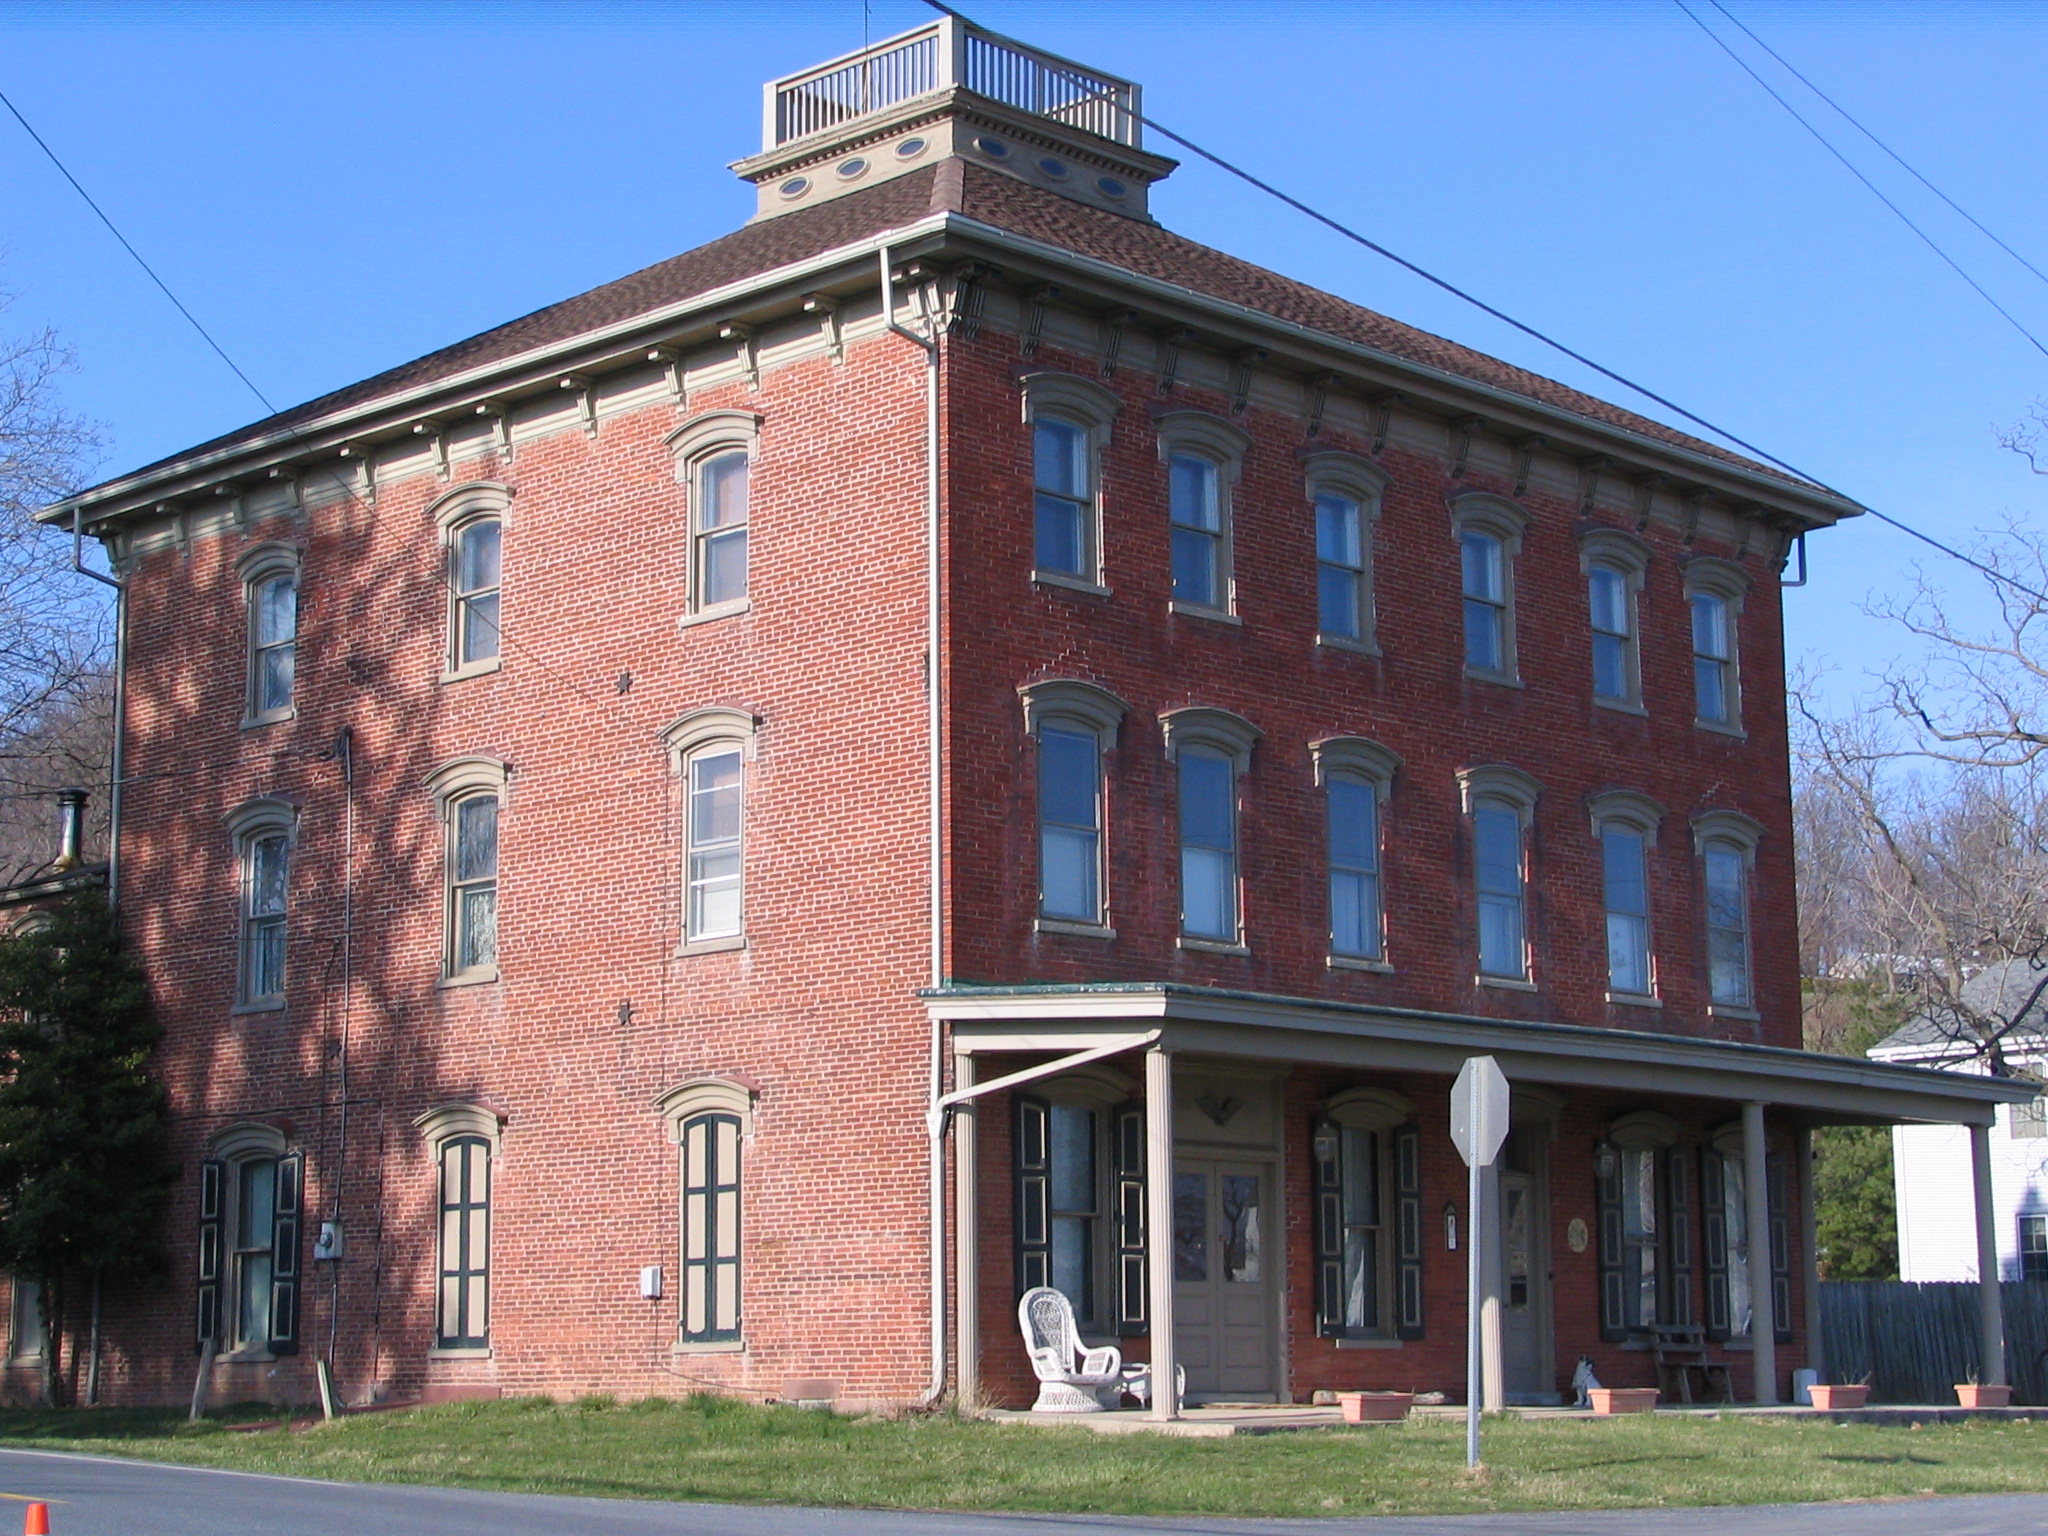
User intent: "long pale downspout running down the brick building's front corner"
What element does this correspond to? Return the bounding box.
[879,244,946,1407]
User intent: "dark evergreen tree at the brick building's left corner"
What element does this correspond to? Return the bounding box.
[0,891,176,1403]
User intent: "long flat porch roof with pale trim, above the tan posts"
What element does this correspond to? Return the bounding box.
[922,981,2038,1124]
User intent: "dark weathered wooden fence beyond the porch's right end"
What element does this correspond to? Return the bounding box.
[1821,1280,2048,1403]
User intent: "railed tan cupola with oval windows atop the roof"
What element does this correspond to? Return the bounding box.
[733,16,1178,219]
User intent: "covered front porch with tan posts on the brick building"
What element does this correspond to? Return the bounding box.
[928,983,2021,1434]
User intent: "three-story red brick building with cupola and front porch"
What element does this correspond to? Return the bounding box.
[32,20,2005,1411]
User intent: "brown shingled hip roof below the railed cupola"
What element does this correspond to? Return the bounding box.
[112,160,1818,495]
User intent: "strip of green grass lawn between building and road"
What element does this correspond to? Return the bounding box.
[0,1397,2048,1516]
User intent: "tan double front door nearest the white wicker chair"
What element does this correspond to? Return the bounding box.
[1174,1159,1280,1401]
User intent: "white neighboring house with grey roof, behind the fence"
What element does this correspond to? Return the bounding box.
[1868,961,2048,1280]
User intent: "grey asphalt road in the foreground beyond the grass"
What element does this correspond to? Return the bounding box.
[0,1450,2048,1536]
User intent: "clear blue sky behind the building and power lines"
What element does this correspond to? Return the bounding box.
[0,0,2048,704]
